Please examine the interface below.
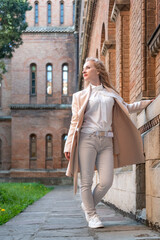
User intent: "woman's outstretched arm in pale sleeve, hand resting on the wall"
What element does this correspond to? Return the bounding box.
[123,100,152,113]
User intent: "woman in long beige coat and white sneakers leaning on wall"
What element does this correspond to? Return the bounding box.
[64,58,152,228]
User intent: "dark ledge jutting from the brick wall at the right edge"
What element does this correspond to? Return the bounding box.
[147,24,160,57]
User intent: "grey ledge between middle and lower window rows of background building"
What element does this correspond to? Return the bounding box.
[10,104,71,110]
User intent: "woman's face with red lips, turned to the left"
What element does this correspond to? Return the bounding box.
[82,61,100,84]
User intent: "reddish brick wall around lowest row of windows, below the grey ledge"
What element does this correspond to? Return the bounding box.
[12,110,71,169]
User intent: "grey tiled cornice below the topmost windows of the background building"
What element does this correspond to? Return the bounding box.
[23,26,75,34]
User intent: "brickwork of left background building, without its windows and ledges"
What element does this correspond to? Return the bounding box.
[0,0,76,174]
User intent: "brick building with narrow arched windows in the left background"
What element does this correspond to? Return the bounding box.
[0,0,78,184]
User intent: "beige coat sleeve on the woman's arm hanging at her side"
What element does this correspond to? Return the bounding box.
[64,94,78,152]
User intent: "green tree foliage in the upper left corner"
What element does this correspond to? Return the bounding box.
[0,0,32,80]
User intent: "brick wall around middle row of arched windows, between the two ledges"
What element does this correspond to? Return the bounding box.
[12,33,76,104]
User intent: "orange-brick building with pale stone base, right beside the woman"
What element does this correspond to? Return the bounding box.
[79,0,160,227]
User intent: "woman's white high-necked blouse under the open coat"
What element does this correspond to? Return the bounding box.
[81,84,114,133]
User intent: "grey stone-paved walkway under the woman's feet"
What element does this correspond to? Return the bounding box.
[0,186,160,240]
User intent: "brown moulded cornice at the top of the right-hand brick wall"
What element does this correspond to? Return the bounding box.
[111,0,130,22]
